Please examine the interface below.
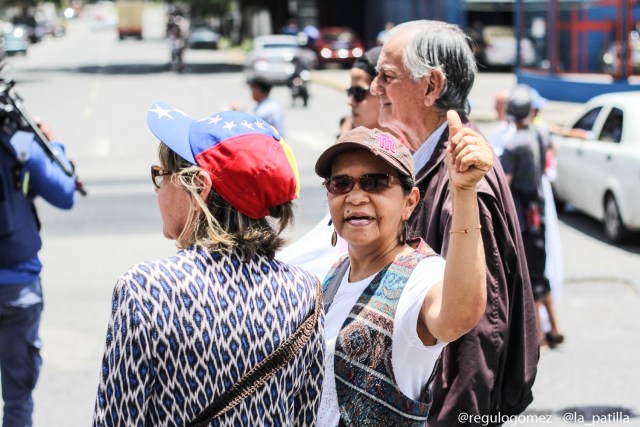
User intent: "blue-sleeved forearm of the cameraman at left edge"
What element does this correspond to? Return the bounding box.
[25,140,76,209]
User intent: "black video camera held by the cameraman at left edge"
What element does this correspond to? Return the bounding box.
[0,62,87,196]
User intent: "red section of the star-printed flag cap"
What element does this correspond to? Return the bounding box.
[196,134,297,219]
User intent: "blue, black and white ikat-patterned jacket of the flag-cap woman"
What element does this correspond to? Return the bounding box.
[93,247,324,427]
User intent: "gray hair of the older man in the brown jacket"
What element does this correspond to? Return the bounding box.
[387,20,478,116]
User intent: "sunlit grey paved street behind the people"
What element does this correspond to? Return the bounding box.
[0,10,640,427]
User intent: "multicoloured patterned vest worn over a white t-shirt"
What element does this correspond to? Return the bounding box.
[323,239,436,427]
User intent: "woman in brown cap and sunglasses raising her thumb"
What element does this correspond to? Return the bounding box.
[315,111,493,427]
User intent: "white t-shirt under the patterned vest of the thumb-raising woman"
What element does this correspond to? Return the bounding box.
[317,256,447,427]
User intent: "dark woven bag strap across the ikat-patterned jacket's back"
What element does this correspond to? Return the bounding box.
[186,280,322,427]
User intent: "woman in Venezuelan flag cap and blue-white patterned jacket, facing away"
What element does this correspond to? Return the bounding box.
[93,103,324,426]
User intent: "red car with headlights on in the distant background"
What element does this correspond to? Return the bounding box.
[316,27,364,67]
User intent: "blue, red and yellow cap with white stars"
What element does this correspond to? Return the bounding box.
[147,103,300,219]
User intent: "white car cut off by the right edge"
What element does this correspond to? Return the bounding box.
[553,92,640,242]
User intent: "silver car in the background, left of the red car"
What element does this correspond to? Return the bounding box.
[245,35,318,85]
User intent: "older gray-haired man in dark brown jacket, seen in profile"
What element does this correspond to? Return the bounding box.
[371,21,539,426]
